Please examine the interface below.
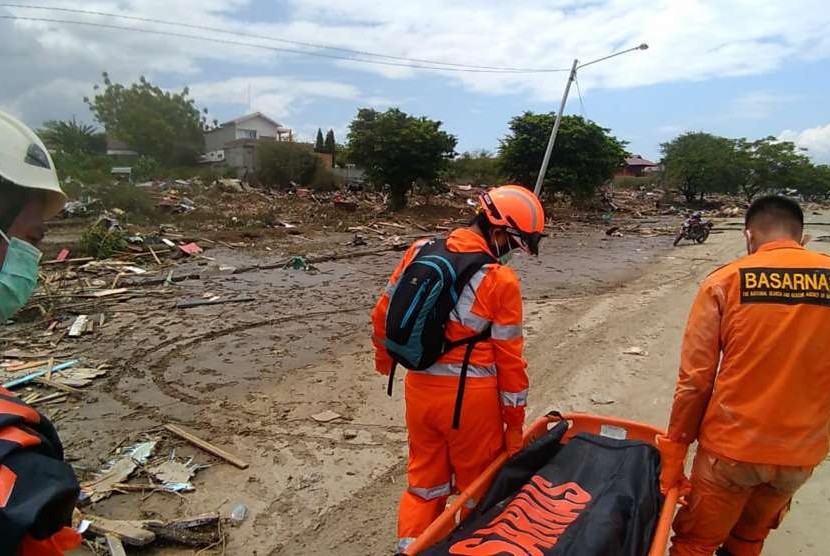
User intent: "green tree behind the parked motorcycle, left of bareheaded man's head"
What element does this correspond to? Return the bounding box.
[660,132,747,201]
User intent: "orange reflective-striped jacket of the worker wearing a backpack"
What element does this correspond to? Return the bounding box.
[372,228,528,427]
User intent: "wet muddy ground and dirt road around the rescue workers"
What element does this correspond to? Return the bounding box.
[8,208,830,556]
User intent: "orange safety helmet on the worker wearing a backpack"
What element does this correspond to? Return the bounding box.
[479,185,545,255]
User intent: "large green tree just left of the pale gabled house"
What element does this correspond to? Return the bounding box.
[84,72,207,165]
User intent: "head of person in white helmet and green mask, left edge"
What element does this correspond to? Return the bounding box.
[0,112,66,325]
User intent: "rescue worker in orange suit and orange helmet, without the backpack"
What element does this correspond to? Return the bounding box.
[372,185,545,551]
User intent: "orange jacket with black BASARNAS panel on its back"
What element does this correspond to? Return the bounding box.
[668,241,830,466]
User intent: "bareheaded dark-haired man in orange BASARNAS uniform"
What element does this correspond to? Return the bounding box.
[658,196,830,556]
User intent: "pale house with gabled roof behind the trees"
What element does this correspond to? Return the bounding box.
[202,112,294,170]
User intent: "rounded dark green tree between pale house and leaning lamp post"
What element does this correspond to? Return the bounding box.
[348,108,457,209]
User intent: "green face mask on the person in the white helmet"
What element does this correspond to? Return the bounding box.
[0,231,43,324]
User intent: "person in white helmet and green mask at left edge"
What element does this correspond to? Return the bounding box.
[0,112,81,556]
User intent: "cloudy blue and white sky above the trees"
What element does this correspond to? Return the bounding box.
[0,0,830,124]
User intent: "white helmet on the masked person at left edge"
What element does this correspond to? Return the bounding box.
[0,112,66,218]
